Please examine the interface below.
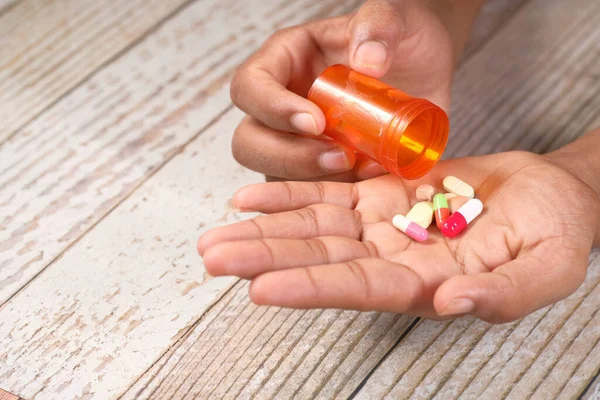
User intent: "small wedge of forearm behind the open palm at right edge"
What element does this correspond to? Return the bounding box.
[546,129,600,246]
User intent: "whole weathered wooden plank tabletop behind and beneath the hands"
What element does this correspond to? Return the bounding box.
[0,0,600,399]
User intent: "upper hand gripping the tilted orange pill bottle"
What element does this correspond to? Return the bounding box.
[231,0,453,181]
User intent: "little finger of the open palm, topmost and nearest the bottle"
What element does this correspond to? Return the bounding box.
[232,182,358,214]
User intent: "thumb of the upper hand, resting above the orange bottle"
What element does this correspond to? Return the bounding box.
[348,0,421,78]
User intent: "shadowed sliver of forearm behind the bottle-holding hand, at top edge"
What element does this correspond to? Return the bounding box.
[427,0,486,63]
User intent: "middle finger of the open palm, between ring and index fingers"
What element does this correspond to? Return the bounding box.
[203,236,377,279]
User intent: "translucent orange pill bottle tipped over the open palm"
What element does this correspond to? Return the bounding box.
[307,65,450,179]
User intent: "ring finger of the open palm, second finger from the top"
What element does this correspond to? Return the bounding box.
[198,204,362,255]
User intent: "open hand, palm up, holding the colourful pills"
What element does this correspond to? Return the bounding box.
[198,152,600,323]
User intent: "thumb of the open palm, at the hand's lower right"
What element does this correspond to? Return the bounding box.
[434,248,587,323]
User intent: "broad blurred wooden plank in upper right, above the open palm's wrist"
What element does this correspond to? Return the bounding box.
[447,0,600,156]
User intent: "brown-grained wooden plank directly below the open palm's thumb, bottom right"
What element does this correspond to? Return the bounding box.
[356,252,600,399]
